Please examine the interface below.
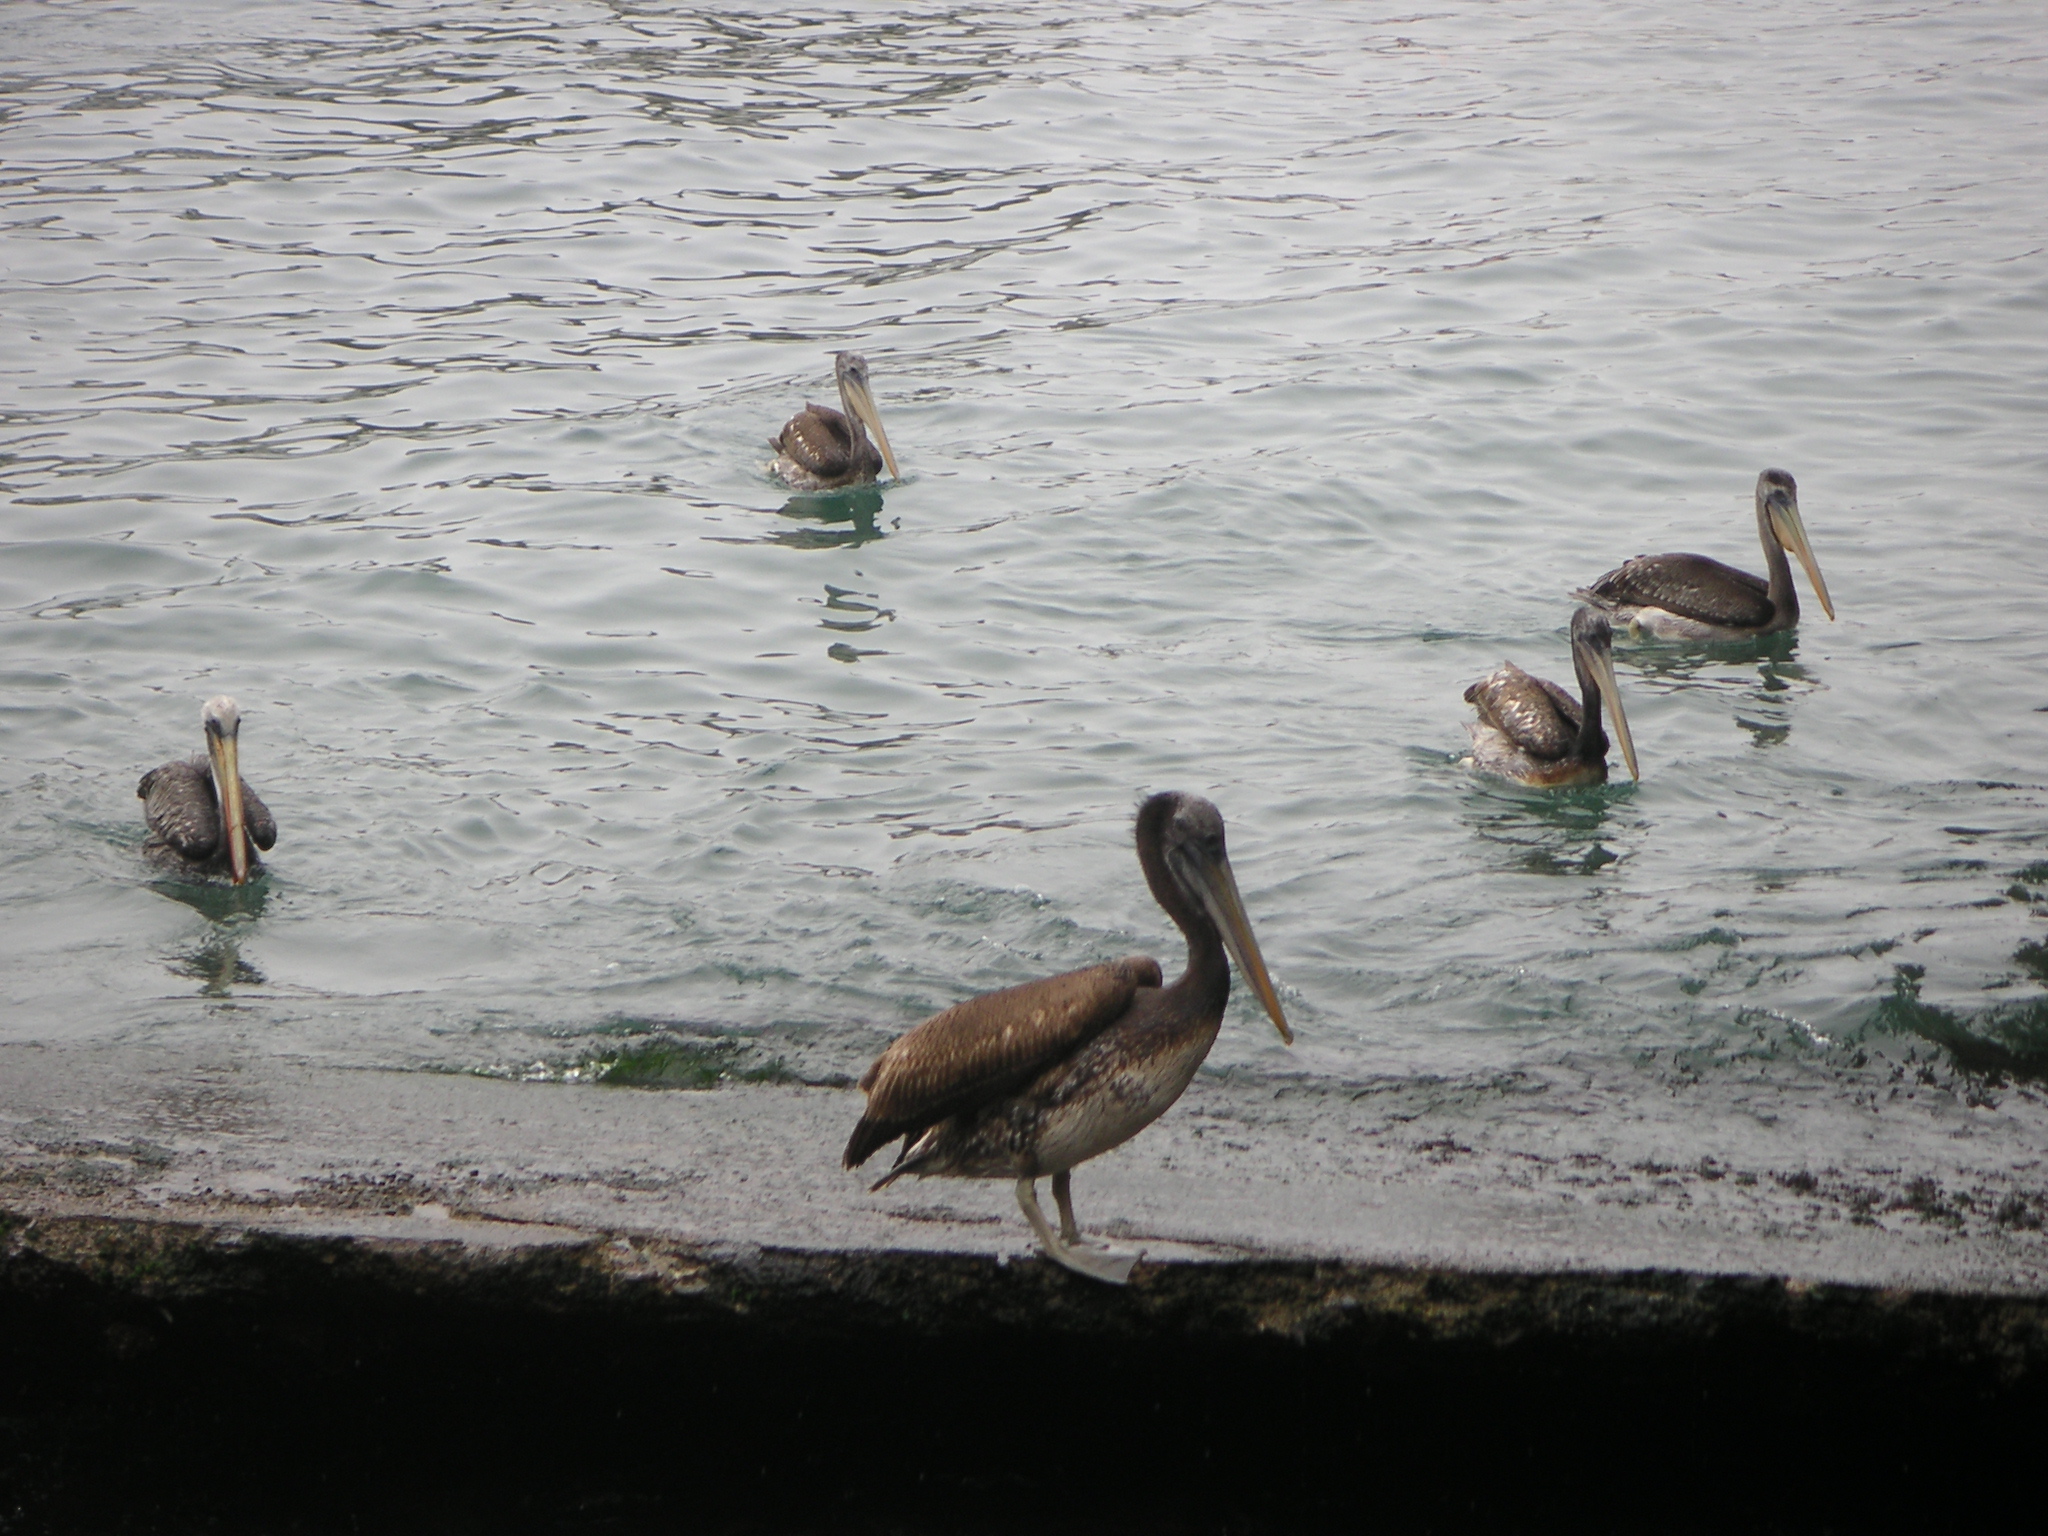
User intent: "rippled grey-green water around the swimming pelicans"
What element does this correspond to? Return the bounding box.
[0,0,2048,1155]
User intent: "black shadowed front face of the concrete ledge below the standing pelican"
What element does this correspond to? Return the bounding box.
[0,1217,2048,1534]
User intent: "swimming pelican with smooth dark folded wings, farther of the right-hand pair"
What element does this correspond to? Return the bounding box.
[1573,469,1835,639]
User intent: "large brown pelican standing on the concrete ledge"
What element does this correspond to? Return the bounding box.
[846,793,1294,1284]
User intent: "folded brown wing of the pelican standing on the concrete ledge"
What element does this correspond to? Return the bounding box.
[846,954,1161,1167]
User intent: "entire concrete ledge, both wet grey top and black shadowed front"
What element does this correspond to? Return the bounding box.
[0,1042,2048,1532]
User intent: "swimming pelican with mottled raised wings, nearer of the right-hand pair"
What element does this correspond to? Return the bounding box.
[1464,608,1642,788]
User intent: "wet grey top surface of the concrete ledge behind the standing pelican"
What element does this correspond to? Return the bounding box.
[0,1040,2048,1294]
